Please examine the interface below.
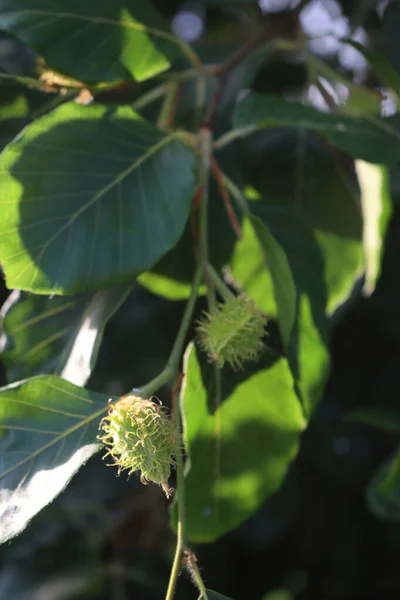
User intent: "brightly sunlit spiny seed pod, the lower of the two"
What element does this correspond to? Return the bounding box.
[98,395,175,498]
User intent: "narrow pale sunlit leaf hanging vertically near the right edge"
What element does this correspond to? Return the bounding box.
[355,160,392,295]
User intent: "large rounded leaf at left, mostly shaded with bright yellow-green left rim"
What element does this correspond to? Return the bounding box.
[0,103,195,294]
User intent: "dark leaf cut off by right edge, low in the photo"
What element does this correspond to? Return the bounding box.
[367,449,400,521]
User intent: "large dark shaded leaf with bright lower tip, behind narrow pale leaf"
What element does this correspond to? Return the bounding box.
[241,128,363,314]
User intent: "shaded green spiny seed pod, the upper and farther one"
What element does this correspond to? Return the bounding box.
[198,296,266,369]
